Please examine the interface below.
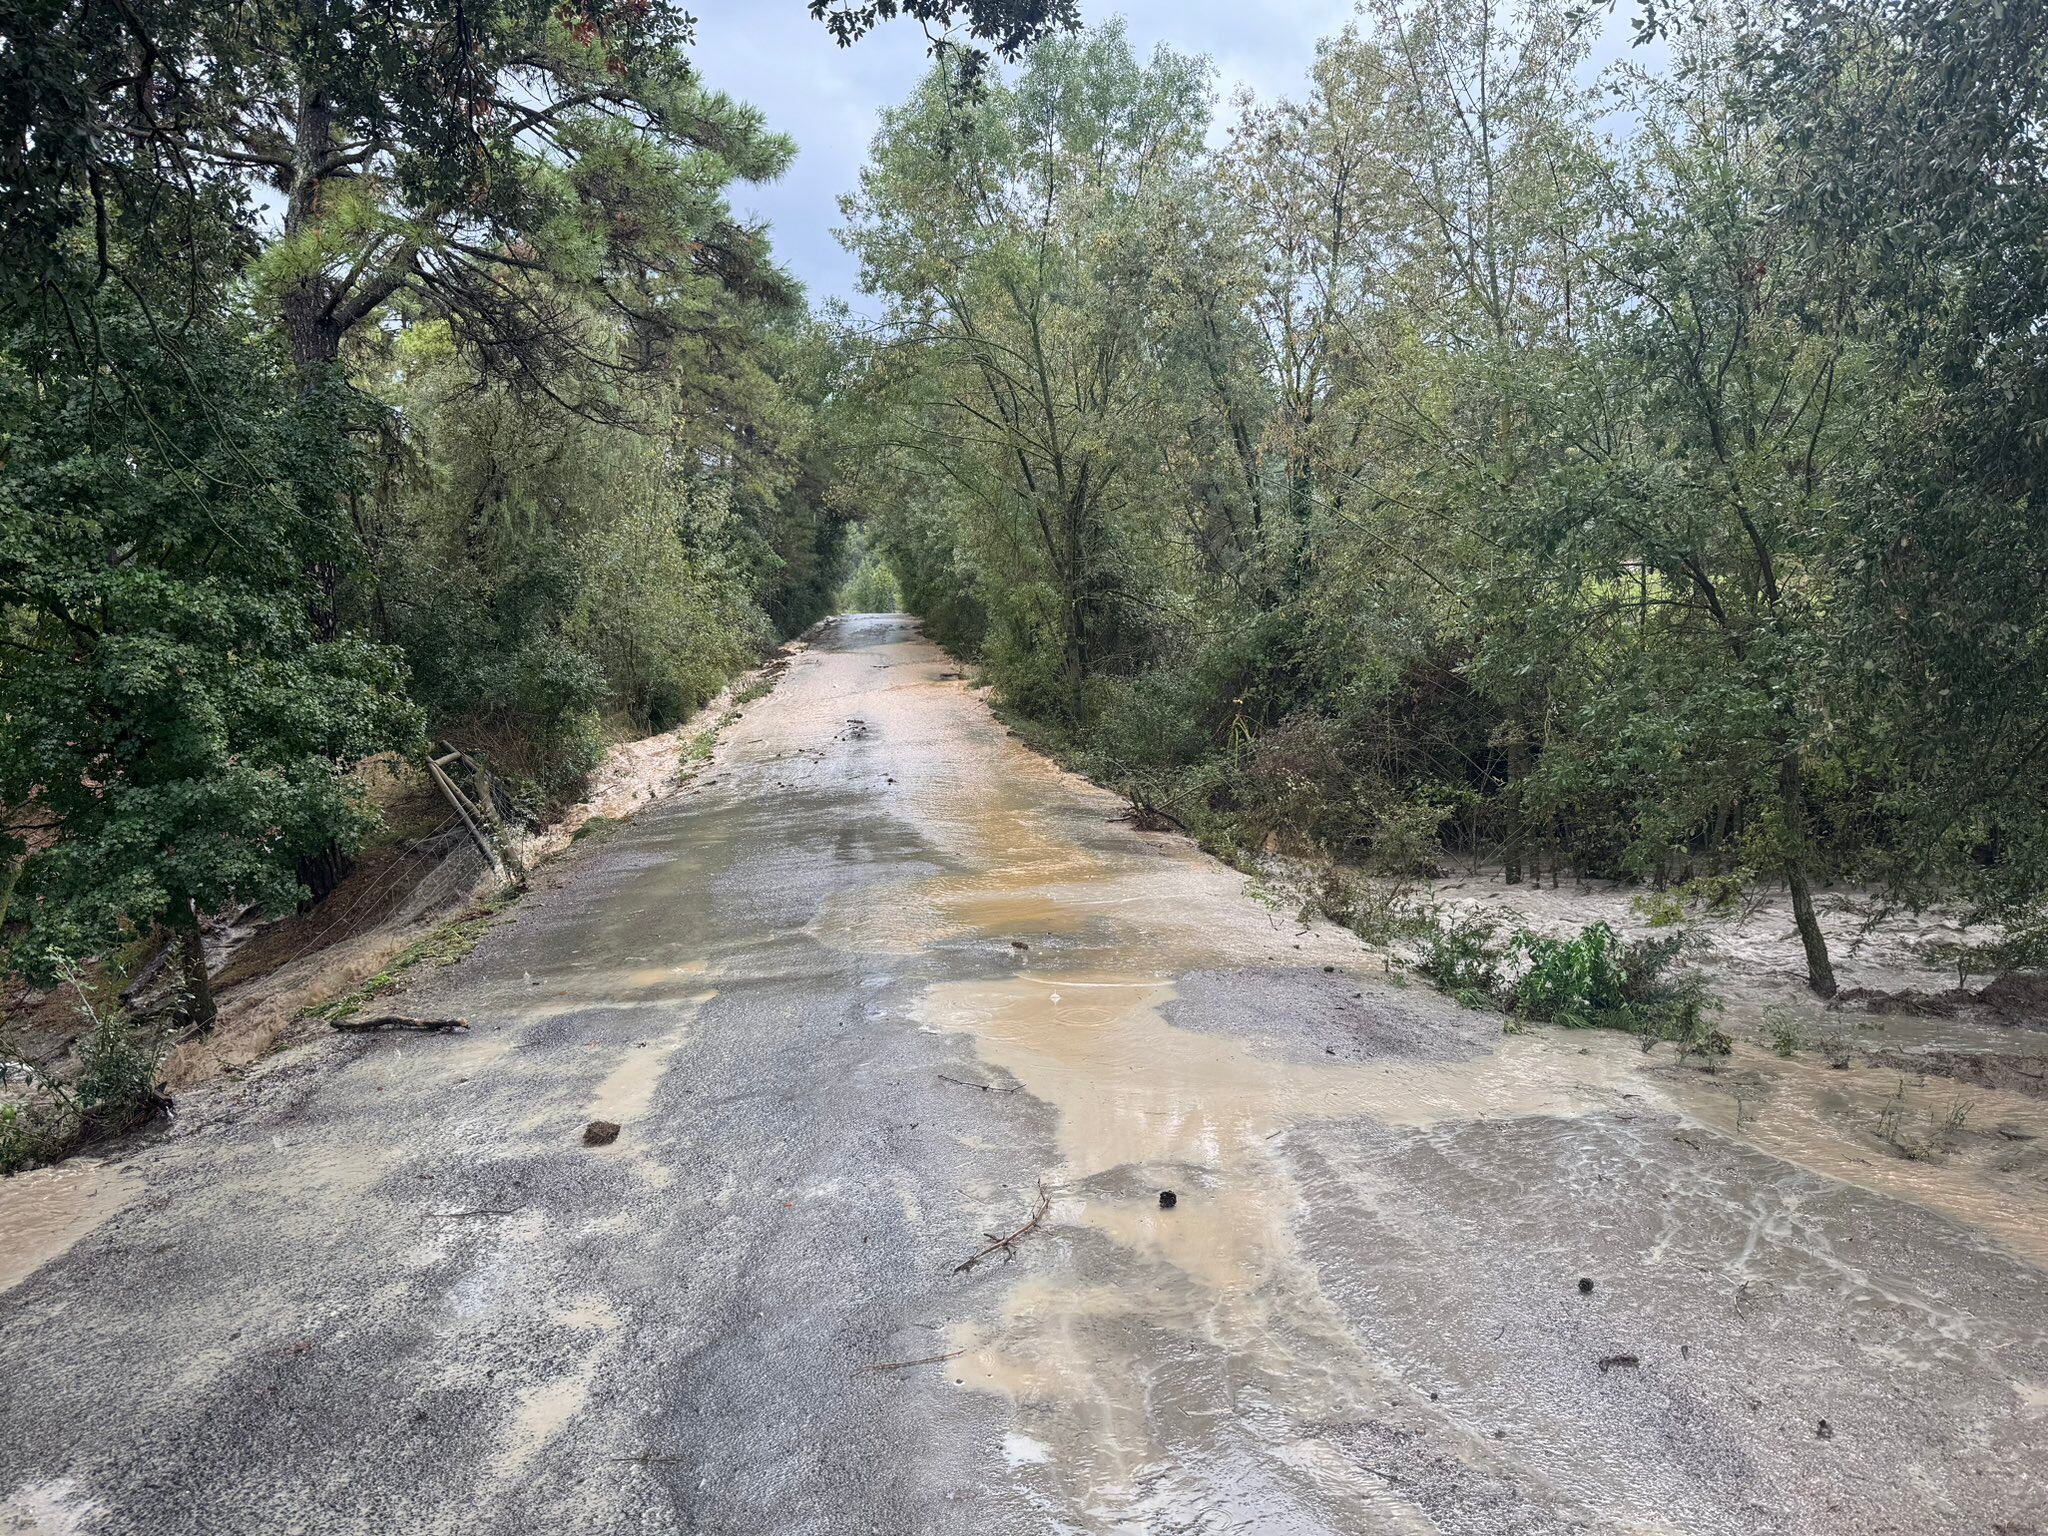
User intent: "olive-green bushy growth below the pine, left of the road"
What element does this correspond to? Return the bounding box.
[373,336,772,797]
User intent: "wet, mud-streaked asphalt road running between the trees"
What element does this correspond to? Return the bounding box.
[0,616,2048,1536]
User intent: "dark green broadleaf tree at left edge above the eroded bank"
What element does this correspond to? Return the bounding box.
[0,299,420,979]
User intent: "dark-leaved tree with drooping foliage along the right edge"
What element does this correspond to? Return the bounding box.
[1749,0,2048,924]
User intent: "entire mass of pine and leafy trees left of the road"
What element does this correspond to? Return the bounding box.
[0,0,880,1036]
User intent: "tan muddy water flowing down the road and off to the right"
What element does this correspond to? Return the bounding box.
[811,643,2048,1532]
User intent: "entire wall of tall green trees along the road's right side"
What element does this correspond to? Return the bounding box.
[846,0,2048,993]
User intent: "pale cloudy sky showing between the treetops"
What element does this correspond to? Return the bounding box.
[690,0,1654,307]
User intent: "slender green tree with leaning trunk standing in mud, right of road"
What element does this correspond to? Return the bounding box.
[1491,55,1870,995]
